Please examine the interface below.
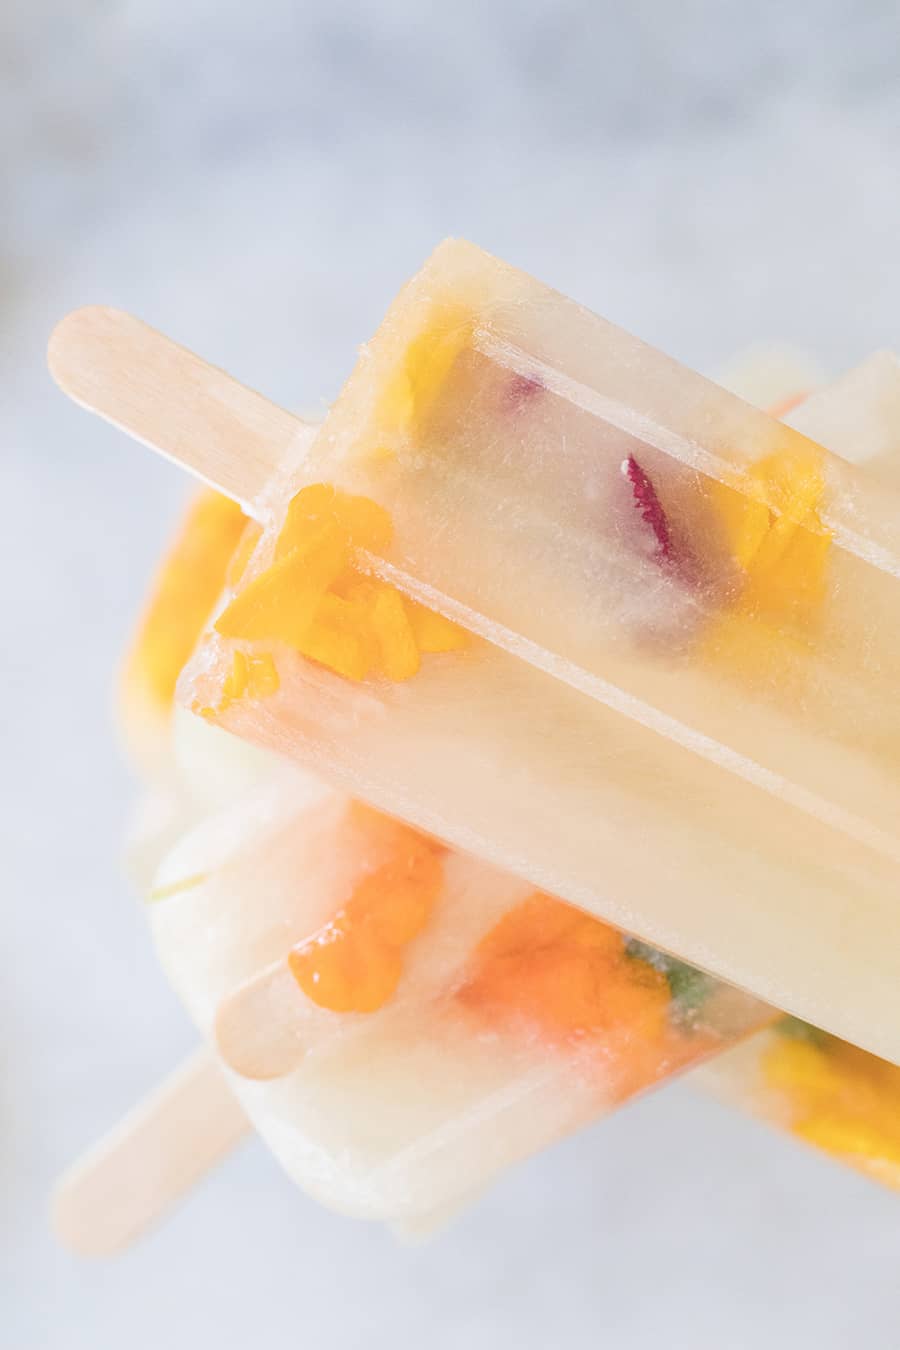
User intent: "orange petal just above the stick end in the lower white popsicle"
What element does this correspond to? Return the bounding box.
[287,829,443,1013]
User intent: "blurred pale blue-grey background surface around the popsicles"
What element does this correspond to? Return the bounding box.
[0,0,900,1350]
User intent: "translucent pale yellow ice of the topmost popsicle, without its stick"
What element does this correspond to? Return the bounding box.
[182,243,900,1057]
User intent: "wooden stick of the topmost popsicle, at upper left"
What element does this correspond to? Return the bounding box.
[47,305,314,516]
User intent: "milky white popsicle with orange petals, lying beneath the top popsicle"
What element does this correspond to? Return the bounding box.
[148,761,772,1229]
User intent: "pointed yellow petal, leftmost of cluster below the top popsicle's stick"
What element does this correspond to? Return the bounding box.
[216,522,348,648]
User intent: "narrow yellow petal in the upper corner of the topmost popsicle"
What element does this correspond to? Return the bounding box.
[375,305,474,433]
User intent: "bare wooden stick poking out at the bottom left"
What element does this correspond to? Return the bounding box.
[53,1048,251,1257]
